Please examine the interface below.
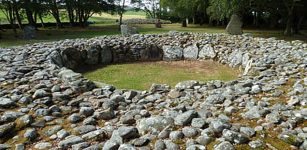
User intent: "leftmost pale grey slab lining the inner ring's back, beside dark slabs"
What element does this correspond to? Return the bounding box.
[162,45,183,61]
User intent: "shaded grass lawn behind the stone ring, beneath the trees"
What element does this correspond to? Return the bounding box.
[0,23,307,47]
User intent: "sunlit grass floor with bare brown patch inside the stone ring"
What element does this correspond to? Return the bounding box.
[84,61,239,90]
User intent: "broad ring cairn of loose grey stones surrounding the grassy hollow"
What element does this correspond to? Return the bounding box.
[0,32,307,149]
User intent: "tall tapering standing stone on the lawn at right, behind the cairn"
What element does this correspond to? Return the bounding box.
[226,14,243,35]
